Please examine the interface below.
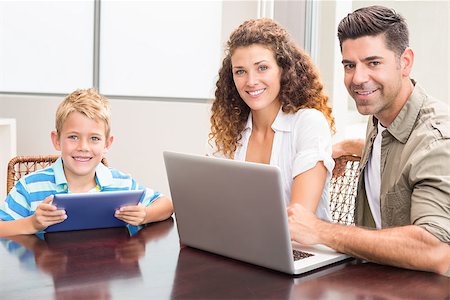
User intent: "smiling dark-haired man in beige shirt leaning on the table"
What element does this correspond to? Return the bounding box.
[288,6,450,275]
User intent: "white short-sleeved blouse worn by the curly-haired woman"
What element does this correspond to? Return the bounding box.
[208,109,334,221]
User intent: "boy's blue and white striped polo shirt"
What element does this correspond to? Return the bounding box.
[0,158,162,221]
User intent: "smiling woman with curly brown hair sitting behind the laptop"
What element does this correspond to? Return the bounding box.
[209,19,334,220]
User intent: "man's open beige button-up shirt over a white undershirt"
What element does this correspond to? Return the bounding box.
[355,85,450,243]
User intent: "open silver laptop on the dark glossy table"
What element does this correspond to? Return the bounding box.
[163,151,349,274]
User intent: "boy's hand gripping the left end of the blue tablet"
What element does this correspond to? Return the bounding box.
[32,195,67,231]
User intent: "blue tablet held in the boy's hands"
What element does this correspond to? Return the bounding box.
[45,190,144,232]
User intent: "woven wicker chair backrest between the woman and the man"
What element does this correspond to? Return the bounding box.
[330,155,361,225]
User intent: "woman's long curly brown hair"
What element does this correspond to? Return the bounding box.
[209,18,334,158]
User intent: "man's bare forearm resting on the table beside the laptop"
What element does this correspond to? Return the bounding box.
[318,222,450,274]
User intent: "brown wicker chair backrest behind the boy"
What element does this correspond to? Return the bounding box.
[6,155,108,194]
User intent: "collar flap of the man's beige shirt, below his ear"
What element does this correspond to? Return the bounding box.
[387,84,427,144]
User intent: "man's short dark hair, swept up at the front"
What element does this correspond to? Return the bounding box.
[338,6,409,57]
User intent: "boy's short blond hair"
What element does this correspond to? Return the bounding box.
[55,88,111,138]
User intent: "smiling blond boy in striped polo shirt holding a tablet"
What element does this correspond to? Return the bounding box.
[0,89,173,237]
